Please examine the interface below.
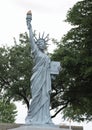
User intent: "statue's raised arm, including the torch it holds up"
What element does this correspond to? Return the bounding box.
[26,11,37,51]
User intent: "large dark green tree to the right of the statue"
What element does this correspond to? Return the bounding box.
[52,0,92,121]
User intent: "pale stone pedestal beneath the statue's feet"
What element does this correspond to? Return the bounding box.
[8,125,69,130]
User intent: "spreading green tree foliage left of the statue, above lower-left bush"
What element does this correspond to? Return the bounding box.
[0,33,33,107]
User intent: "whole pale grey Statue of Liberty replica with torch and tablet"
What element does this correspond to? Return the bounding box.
[25,11,60,125]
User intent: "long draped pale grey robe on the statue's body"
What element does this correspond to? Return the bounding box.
[26,47,53,124]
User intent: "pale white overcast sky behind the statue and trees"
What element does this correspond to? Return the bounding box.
[0,0,92,130]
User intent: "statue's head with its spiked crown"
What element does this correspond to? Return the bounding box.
[35,33,49,51]
